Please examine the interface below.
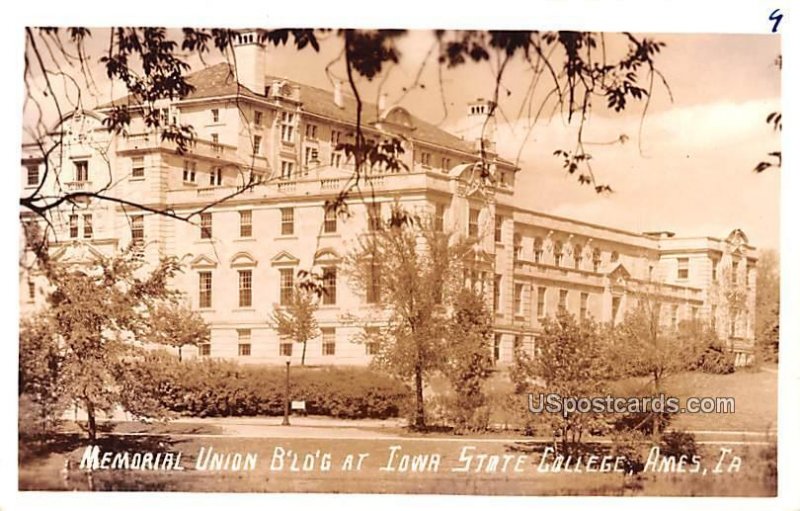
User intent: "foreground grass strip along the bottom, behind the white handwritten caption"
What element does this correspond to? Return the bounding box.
[19,435,775,496]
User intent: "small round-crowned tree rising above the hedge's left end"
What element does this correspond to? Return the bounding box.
[144,302,211,361]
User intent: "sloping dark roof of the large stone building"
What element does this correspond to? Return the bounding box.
[98,62,514,165]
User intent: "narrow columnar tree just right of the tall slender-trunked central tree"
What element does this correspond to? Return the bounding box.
[443,288,494,431]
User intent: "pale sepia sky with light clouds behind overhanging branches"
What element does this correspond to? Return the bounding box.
[24,29,781,248]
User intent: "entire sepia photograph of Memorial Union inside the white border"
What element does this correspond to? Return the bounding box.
[12,9,784,498]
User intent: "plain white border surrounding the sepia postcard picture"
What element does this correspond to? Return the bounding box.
[0,0,800,510]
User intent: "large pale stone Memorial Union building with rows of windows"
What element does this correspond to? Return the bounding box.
[20,34,756,365]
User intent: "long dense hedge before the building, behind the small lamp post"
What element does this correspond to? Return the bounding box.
[131,355,409,419]
